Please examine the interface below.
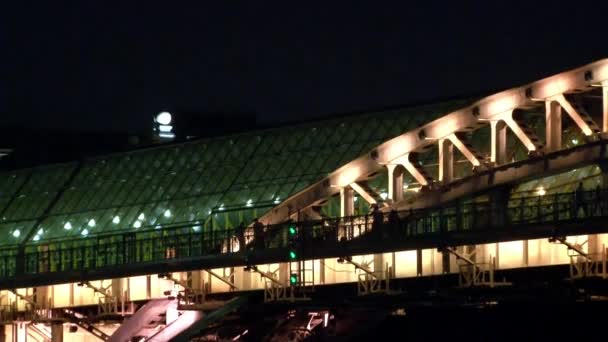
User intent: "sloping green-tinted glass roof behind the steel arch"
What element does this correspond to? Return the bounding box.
[0,100,470,247]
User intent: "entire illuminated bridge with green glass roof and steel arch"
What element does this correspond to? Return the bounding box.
[0,60,608,341]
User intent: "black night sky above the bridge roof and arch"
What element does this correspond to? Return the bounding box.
[0,1,608,131]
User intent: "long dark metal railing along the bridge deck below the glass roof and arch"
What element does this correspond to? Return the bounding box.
[0,189,608,278]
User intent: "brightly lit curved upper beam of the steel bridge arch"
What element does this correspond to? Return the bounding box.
[260,59,608,223]
